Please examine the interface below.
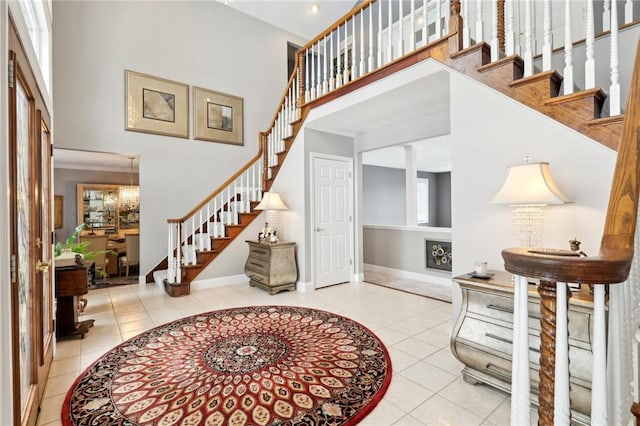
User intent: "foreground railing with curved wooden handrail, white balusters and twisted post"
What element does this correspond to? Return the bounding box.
[502,38,640,425]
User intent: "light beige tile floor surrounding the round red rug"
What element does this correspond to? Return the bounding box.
[38,283,524,426]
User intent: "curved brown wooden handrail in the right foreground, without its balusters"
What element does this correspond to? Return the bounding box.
[502,37,640,284]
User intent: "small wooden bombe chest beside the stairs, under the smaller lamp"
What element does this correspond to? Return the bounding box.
[244,241,298,294]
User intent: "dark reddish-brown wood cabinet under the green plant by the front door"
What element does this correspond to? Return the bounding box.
[55,263,94,340]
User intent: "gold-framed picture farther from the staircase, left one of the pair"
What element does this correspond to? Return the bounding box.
[124,70,189,139]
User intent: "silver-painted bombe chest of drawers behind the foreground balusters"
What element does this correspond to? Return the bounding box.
[451,271,593,425]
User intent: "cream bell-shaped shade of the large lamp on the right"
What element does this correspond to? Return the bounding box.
[491,163,569,206]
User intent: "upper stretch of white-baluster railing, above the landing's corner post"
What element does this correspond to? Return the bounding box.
[299,0,638,116]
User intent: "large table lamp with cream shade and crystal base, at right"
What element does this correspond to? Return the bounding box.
[491,158,568,247]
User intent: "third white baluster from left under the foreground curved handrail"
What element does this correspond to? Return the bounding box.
[591,285,609,425]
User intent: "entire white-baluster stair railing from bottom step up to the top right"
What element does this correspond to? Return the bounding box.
[167,0,633,283]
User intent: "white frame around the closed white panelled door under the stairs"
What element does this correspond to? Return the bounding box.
[309,152,356,290]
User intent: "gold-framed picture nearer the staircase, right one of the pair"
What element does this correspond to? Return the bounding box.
[193,86,244,145]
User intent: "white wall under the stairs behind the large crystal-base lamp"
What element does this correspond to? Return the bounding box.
[451,65,616,312]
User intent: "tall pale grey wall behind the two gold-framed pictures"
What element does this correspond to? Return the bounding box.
[53,1,302,274]
